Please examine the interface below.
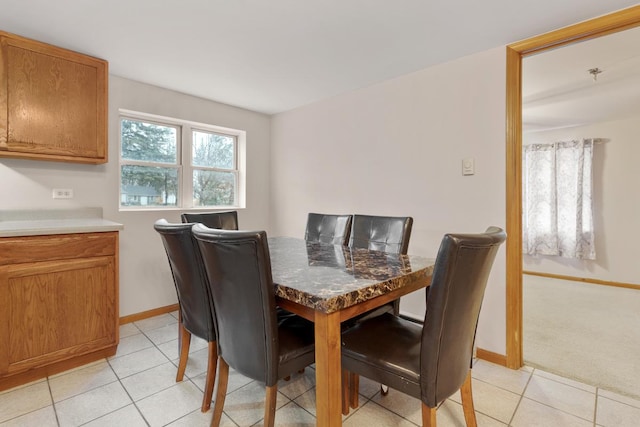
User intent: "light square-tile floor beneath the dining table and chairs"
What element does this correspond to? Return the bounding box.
[0,313,640,427]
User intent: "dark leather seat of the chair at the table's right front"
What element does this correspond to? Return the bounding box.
[342,313,422,397]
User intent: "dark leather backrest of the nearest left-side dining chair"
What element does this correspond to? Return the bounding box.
[193,224,278,386]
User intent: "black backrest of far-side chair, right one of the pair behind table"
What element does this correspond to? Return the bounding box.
[349,215,413,255]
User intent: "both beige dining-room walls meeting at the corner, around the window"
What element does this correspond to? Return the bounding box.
[0,47,505,354]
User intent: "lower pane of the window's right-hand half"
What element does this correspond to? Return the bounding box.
[193,170,236,206]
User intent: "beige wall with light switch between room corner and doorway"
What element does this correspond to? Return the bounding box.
[271,47,506,354]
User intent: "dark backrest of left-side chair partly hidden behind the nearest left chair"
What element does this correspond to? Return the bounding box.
[153,219,216,341]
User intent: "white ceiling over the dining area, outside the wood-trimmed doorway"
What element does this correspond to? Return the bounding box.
[0,0,637,114]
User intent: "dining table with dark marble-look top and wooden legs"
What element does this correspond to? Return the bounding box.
[269,237,435,427]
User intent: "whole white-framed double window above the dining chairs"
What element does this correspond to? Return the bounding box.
[120,111,245,209]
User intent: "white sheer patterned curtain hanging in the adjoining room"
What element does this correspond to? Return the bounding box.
[522,139,596,259]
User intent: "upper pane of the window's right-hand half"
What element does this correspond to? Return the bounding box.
[192,131,236,169]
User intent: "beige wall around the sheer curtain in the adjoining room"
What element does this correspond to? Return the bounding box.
[523,116,640,284]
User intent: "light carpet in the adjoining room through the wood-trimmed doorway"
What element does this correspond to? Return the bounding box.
[523,274,640,399]
